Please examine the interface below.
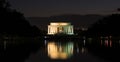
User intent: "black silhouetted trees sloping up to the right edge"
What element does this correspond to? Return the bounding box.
[85,14,120,37]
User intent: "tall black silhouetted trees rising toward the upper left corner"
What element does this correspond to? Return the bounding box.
[0,0,45,37]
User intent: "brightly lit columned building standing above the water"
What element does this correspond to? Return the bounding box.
[48,22,74,35]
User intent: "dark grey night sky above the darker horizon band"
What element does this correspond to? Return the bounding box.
[8,0,120,17]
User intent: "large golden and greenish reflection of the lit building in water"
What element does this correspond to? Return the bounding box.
[47,42,73,59]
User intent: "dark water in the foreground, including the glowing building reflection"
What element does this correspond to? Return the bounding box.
[3,39,120,62]
